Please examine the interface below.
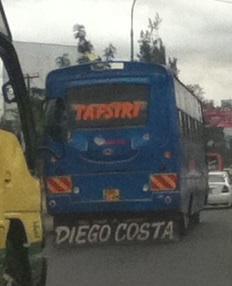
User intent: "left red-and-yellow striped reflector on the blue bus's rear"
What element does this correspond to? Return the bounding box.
[47,177,72,193]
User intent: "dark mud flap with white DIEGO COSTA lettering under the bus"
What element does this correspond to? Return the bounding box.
[54,214,179,247]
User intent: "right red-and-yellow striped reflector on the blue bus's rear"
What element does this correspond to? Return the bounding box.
[150,174,177,191]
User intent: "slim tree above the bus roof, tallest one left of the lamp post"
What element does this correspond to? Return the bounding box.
[73,24,101,64]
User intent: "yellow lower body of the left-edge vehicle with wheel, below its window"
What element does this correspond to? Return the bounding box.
[0,130,44,286]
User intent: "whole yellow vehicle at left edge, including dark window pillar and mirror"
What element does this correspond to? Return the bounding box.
[0,1,46,286]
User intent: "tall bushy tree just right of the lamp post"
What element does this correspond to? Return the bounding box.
[138,13,166,64]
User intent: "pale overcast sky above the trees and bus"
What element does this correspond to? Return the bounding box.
[2,0,232,105]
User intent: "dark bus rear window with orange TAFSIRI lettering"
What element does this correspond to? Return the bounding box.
[67,84,149,129]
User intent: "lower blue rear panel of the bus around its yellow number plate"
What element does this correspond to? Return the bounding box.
[47,172,180,214]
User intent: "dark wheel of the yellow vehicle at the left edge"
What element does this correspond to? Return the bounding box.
[4,221,31,286]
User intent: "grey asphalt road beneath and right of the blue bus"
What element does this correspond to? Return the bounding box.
[42,209,232,286]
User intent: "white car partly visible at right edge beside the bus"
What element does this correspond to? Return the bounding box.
[208,171,232,207]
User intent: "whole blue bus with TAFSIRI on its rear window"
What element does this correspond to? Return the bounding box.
[43,62,208,245]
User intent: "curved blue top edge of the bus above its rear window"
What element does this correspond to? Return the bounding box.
[46,61,172,97]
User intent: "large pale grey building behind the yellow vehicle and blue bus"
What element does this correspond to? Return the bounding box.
[0,41,78,132]
